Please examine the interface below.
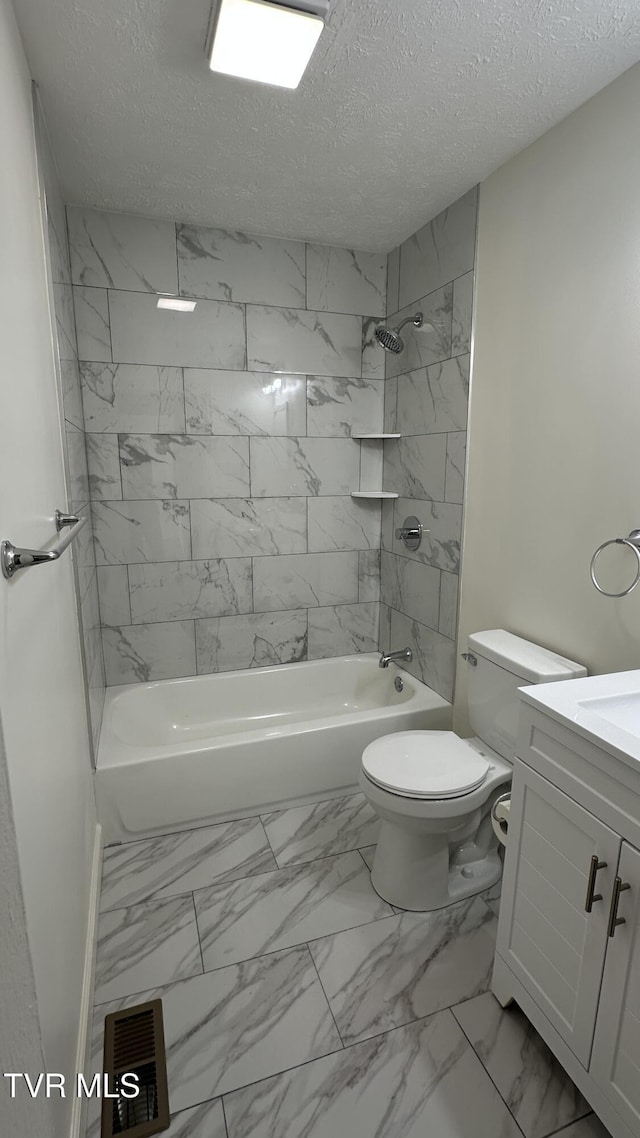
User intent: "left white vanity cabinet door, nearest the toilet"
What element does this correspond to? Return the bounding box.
[498,761,621,1067]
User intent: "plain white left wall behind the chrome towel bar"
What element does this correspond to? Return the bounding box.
[0,0,96,1138]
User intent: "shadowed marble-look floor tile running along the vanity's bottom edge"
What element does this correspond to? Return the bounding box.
[452,992,591,1138]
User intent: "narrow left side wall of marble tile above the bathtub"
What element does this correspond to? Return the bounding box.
[35,104,105,752]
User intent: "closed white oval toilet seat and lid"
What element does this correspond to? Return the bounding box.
[362,731,491,799]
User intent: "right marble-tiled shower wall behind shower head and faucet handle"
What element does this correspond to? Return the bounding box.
[380,189,477,699]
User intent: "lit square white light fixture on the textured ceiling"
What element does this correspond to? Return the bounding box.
[207,0,329,89]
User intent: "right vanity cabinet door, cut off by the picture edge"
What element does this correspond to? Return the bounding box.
[591,842,640,1133]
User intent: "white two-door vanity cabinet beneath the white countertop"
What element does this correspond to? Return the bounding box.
[493,704,640,1138]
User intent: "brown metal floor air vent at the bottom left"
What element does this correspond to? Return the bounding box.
[100,999,171,1138]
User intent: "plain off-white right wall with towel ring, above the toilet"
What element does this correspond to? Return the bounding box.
[457,66,640,726]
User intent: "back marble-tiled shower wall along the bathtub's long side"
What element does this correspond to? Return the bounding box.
[67,207,386,684]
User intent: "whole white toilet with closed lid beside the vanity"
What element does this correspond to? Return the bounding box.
[360,628,586,912]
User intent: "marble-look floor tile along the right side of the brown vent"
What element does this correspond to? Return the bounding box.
[96,947,341,1110]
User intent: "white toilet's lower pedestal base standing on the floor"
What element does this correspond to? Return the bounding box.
[371,819,502,913]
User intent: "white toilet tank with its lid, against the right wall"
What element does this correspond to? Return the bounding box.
[460,628,586,762]
